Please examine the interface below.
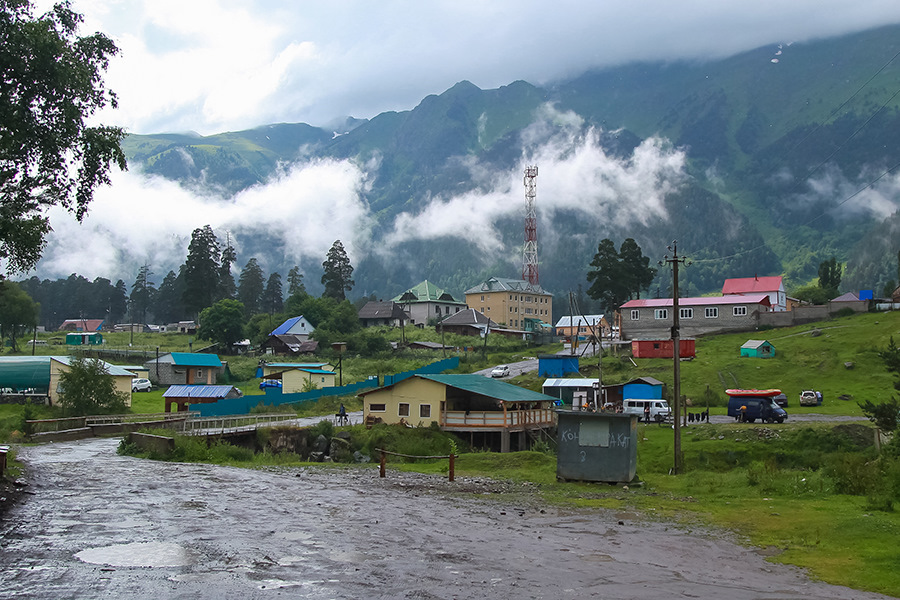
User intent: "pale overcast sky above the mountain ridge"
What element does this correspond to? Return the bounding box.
[65,0,900,135]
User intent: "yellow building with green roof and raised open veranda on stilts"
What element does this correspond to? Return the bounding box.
[360,375,556,452]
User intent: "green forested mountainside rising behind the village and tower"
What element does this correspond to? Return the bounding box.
[111,27,900,308]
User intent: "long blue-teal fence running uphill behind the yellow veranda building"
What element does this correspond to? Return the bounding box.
[189,356,459,417]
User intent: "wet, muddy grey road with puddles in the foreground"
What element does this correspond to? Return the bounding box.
[0,439,882,600]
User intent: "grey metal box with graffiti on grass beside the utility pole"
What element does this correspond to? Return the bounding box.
[556,410,637,483]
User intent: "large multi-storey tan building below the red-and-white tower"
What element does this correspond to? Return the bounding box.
[465,277,553,329]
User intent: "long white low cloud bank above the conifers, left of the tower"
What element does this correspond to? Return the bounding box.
[36,160,369,280]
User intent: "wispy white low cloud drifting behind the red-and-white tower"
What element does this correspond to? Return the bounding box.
[383,110,686,258]
